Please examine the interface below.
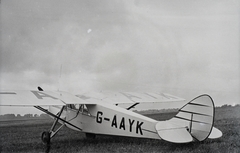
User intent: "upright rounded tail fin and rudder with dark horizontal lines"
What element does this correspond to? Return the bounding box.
[171,94,215,141]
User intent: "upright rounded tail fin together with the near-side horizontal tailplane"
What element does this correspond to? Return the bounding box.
[156,95,220,143]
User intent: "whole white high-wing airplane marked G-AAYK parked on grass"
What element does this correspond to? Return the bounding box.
[0,87,222,148]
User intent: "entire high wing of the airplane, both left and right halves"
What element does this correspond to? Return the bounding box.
[0,90,184,110]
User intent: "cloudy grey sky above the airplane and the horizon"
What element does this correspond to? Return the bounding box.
[0,0,240,114]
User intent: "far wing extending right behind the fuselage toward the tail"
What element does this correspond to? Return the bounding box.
[76,91,185,110]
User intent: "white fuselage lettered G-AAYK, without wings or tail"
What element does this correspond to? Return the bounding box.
[49,103,160,139]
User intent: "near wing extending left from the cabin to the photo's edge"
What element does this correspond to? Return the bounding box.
[0,91,95,106]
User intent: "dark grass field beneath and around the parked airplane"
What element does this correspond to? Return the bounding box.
[0,106,240,153]
